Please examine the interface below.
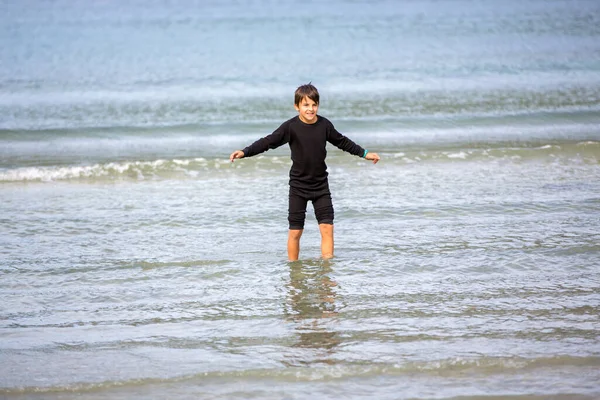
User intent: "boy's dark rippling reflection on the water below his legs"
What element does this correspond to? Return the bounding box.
[285,260,340,365]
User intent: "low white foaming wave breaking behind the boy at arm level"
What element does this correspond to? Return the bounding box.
[0,140,600,182]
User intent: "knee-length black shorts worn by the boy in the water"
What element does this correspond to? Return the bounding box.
[288,186,333,229]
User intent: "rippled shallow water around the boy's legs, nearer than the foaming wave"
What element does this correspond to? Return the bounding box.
[1,143,600,398]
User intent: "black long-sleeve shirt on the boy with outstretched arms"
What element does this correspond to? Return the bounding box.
[242,115,365,191]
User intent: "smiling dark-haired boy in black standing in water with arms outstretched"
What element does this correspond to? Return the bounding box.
[229,83,379,261]
